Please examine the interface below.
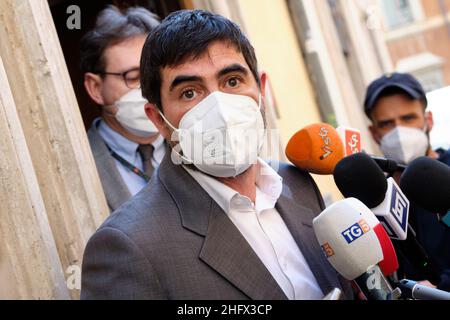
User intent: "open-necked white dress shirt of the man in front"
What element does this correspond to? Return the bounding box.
[184,159,324,300]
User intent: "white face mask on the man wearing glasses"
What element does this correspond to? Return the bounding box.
[114,89,158,137]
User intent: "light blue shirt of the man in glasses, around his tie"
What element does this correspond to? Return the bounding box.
[94,118,166,196]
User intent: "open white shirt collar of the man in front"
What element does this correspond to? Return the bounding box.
[183,159,283,214]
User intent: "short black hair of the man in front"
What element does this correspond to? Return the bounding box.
[141,10,260,109]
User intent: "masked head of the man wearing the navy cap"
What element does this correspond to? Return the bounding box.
[364,73,440,164]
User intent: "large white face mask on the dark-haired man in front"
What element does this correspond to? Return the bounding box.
[161,91,265,178]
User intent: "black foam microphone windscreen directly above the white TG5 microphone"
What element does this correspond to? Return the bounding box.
[333,153,387,208]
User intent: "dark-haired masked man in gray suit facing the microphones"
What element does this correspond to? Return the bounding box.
[81,10,353,300]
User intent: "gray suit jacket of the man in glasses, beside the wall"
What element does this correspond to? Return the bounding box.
[88,125,131,212]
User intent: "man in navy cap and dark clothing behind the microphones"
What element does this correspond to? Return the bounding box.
[364,73,450,290]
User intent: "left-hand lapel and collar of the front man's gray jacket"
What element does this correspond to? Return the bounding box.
[158,155,287,300]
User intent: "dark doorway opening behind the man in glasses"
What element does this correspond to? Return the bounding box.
[48,0,183,130]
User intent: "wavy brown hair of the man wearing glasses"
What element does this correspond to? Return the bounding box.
[80,5,160,74]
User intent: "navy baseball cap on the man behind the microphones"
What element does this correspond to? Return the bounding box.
[364,73,428,118]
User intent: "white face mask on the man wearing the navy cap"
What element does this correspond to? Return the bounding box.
[380,126,429,165]
